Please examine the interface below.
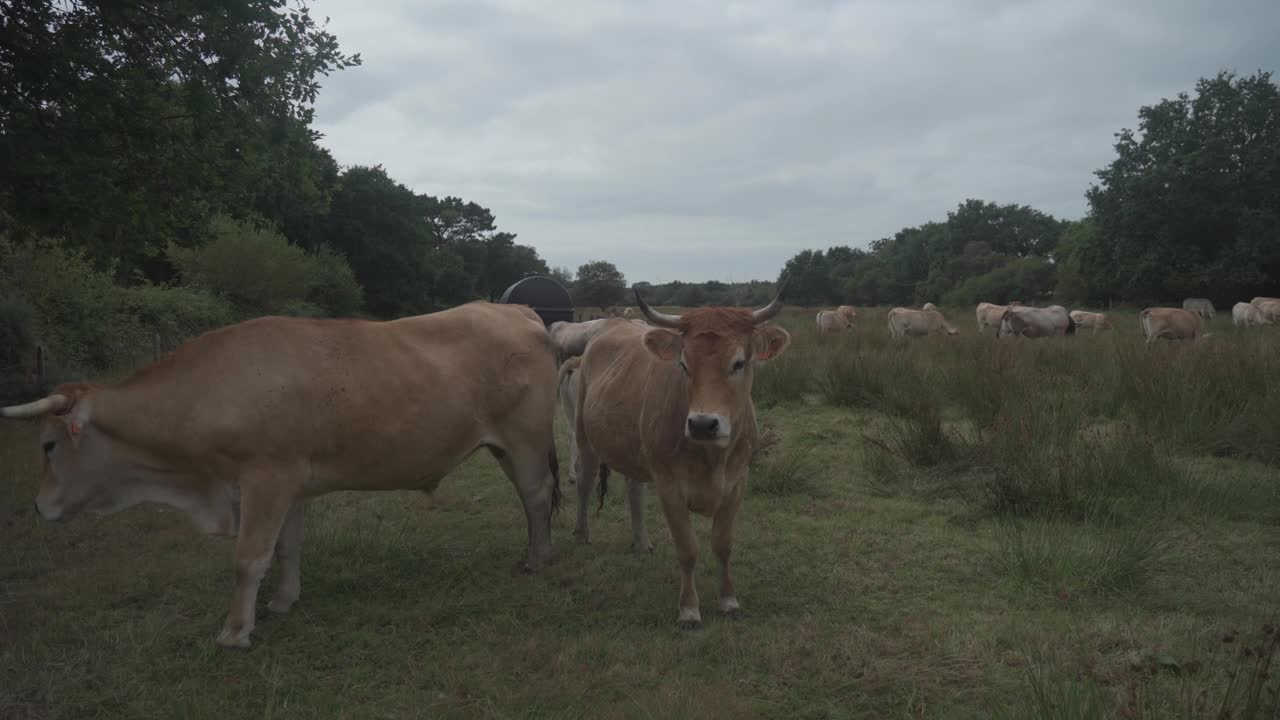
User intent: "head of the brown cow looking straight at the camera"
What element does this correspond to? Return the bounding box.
[632,281,791,447]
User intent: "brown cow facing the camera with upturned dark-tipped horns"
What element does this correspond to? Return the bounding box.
[575,283,791,629]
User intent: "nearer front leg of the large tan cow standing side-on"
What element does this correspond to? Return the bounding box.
[218,477,293,648]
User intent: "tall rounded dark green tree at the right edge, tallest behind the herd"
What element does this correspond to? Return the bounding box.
[1074,72,1280,304]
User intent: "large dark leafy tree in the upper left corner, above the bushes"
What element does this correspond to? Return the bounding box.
[0,0,360,279]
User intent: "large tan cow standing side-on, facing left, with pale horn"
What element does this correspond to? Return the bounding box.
[0,302,560,647]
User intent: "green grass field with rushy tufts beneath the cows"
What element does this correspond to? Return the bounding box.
[0,303,1280,720]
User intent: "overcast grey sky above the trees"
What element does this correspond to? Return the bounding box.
[312,0,1280,282]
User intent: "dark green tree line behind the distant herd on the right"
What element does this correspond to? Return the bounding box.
[782,70,1280,306]
